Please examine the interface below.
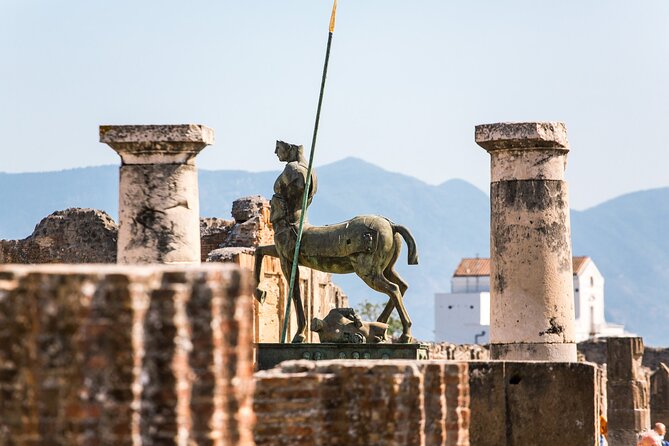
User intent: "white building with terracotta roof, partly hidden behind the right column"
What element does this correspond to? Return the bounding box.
[434,257,624,344]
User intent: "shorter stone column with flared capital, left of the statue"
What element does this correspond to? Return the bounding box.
[100,124,214,264]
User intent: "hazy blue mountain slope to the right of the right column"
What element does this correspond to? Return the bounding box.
[571,188,669,345]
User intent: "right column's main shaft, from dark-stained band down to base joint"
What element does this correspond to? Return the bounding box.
[490,180,576,344]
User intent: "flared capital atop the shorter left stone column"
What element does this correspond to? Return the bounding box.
[100,124,214,164]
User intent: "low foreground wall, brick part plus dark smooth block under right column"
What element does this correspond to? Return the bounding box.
[254,360,600,446]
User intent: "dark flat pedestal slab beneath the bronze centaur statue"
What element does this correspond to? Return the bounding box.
[256,343,429,370]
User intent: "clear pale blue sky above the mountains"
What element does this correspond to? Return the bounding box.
[0,0,669,209]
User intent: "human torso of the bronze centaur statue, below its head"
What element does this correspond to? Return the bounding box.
[270,161,317,231]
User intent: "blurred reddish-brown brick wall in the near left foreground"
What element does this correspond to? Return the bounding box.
[0,265,253,445]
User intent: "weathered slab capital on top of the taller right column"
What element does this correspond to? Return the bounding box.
[475,121,569,152]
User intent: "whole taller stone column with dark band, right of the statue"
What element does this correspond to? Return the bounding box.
[476,122,576,361]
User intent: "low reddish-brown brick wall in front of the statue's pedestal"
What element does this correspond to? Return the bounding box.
[254,360,469,446]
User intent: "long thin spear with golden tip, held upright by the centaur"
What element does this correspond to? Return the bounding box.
[281,0,337,344]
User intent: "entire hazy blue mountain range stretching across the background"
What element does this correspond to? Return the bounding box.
[0,158,669,345]
